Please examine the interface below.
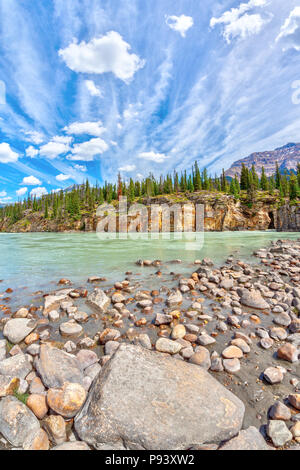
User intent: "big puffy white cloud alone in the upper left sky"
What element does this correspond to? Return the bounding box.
[59,31,145,82]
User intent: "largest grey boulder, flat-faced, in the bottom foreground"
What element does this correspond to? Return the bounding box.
[75,344,245,450]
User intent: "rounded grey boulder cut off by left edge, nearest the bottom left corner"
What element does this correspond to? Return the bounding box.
[0,397,40,447]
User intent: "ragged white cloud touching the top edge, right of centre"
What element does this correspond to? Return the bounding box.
[210,0,271,43]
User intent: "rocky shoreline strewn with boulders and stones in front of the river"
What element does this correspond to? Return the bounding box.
[0,239,300,450]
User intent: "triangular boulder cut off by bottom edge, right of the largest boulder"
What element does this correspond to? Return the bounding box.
[219,426,272,450]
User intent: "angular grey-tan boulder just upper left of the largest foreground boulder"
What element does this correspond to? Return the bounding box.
[35,344,84,388]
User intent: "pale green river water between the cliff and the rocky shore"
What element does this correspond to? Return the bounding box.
[0,232,300,290]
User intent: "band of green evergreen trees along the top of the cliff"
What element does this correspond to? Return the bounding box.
[0,162,300,225]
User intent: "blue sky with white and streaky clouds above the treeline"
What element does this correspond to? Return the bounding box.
[0,0,300,204]
